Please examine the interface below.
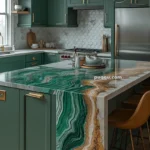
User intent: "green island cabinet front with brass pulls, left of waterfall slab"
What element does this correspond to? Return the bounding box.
[0,86,51,150]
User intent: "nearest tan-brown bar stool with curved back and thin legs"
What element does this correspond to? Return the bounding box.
[108,91,150,150]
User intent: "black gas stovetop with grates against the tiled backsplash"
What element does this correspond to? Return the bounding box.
[64,48,101,53]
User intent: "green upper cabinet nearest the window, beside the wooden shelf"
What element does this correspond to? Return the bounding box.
[18,0,48,27]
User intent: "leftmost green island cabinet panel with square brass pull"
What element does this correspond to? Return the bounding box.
[0,86,20,150]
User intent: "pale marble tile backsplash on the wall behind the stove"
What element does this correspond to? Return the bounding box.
[13,1,111,49]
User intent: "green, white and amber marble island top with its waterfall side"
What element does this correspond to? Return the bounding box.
[0,59,150,150]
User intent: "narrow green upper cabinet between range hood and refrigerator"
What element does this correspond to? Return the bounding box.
[104,0,115,28]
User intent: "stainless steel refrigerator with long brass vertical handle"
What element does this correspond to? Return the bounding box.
[115,8,150,61]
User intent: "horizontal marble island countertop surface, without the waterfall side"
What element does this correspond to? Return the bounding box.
[0,59,150,100]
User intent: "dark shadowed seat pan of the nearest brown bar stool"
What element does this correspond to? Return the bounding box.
[108,108,135,128]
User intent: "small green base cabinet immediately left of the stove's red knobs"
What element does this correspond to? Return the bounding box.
[44,53,60,64]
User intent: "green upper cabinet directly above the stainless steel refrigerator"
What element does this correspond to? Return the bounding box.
[115,0,149,8]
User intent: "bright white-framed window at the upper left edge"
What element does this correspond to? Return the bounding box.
[0,0,10,45]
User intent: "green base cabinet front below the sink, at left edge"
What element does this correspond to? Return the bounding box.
[0,56,25,72]
